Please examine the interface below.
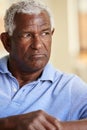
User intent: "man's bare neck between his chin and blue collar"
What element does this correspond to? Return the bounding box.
[8,59,43,87]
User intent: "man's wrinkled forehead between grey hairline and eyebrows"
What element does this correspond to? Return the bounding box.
[14,11,51,28]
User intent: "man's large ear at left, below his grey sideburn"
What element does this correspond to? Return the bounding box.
[0,32,11,52]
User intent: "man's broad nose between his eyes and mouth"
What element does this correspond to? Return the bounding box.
[31,34,42,49]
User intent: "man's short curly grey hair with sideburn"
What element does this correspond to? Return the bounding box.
[4,0,54,35]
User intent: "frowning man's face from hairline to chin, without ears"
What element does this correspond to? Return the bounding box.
[10,11,53,72]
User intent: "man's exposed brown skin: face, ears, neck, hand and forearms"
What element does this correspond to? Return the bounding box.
[0,11,87,130]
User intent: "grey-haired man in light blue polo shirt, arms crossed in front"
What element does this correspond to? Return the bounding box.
[0,0,87,130]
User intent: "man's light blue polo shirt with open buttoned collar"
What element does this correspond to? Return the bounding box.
[0,57,87,121]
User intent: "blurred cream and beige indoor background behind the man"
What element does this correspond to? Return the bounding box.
[0,0,87,82]
